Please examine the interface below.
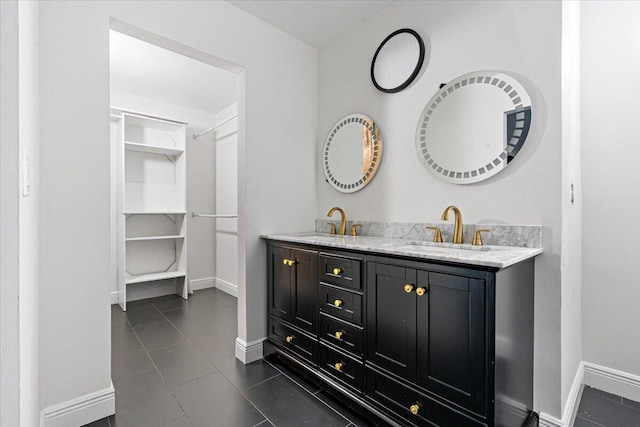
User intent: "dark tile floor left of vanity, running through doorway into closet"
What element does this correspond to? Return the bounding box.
[89,289,366,427]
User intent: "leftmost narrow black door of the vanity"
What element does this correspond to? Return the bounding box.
[268,246,293,320]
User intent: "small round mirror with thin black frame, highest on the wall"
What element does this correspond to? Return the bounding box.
[371,28,424,93]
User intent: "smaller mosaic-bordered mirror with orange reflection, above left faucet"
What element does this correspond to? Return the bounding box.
[322,114,382,193]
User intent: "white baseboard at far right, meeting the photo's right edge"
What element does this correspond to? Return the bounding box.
[584,362,640,402]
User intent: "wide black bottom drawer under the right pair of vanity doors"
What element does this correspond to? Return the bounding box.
[366,368,486,427]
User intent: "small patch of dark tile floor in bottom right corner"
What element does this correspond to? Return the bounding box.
[573,385,640,427]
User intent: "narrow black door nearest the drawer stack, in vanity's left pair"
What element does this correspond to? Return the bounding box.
[289,249,318,335]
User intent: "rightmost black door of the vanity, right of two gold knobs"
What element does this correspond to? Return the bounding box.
[416,271,487,415]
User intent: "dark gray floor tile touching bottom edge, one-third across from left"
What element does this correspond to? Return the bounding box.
[173,372,264,427]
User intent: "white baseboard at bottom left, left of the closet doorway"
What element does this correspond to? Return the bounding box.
[40,383,116,427]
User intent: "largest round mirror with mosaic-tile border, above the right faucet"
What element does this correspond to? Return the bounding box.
[416,71,531,184]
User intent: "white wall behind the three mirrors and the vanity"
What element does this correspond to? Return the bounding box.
[315,1,562,416]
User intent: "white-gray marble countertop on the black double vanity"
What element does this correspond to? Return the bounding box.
[260,232,542,268]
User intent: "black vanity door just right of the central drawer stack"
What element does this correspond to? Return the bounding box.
[366,263,416,381]
